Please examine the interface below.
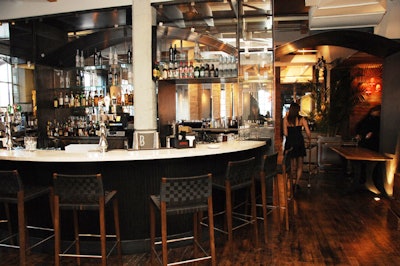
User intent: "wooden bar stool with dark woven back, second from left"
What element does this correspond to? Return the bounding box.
[53,173,122,266]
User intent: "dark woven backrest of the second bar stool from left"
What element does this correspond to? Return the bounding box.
[53,173,104,204]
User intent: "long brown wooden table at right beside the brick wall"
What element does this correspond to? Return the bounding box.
[330,145,393,194]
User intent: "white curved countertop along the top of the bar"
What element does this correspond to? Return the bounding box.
[0,141,265,162]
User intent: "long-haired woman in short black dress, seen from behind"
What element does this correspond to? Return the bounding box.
[283,103,311,189]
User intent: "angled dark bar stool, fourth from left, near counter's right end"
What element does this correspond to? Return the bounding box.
[208,157,258,246]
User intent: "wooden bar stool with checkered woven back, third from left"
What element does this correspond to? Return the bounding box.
[150,174,216,265]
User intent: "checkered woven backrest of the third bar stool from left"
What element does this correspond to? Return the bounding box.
[160,174,212,212]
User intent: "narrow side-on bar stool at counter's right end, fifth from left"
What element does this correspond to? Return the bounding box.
[256,152,281,244]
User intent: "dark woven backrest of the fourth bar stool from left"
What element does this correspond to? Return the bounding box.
[225,157,256,187]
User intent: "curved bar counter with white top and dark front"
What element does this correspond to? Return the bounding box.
[0,141,268,253]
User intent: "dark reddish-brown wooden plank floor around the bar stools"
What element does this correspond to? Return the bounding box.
[0,169,400,266]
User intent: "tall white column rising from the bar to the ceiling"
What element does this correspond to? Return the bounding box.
[132,0,157,131]
